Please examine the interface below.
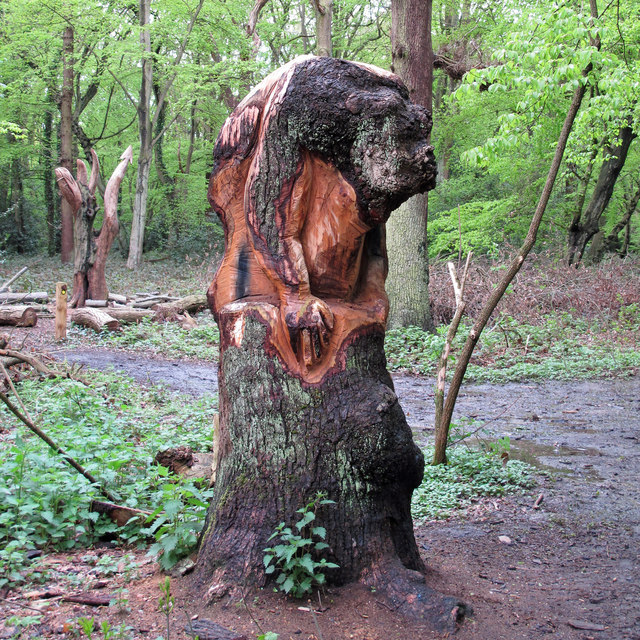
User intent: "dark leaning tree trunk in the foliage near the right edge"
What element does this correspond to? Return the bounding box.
[568,126,636,264]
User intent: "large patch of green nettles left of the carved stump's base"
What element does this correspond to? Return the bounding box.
[0,371,217,586]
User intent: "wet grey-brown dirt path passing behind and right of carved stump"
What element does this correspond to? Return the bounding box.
[55,350,640,640]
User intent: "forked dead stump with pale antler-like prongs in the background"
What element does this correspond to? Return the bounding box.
[56,147,132,307]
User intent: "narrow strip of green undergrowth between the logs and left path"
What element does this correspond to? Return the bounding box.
[68,311,220,361]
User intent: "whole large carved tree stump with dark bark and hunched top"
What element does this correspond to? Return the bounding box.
[194,56,464,628]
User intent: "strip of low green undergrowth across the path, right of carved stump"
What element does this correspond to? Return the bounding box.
[385,304,640,383]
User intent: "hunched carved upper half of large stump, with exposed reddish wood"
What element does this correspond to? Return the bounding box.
[209,57,436,382]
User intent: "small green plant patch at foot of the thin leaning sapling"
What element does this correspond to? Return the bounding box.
[411,445,535,522]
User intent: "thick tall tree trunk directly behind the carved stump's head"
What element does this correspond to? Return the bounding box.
[387,0,433,329]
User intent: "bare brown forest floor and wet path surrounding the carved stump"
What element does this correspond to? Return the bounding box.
[0,256,640,640]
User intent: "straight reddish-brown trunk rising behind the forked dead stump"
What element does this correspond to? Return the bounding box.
[60,27,74,262]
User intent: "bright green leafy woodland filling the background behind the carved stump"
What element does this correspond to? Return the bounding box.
[0,0,640,276]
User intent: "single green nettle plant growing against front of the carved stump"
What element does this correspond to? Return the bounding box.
[263,492,339,598]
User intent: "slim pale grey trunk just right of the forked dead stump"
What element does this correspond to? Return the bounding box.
[127,0,153,269]
